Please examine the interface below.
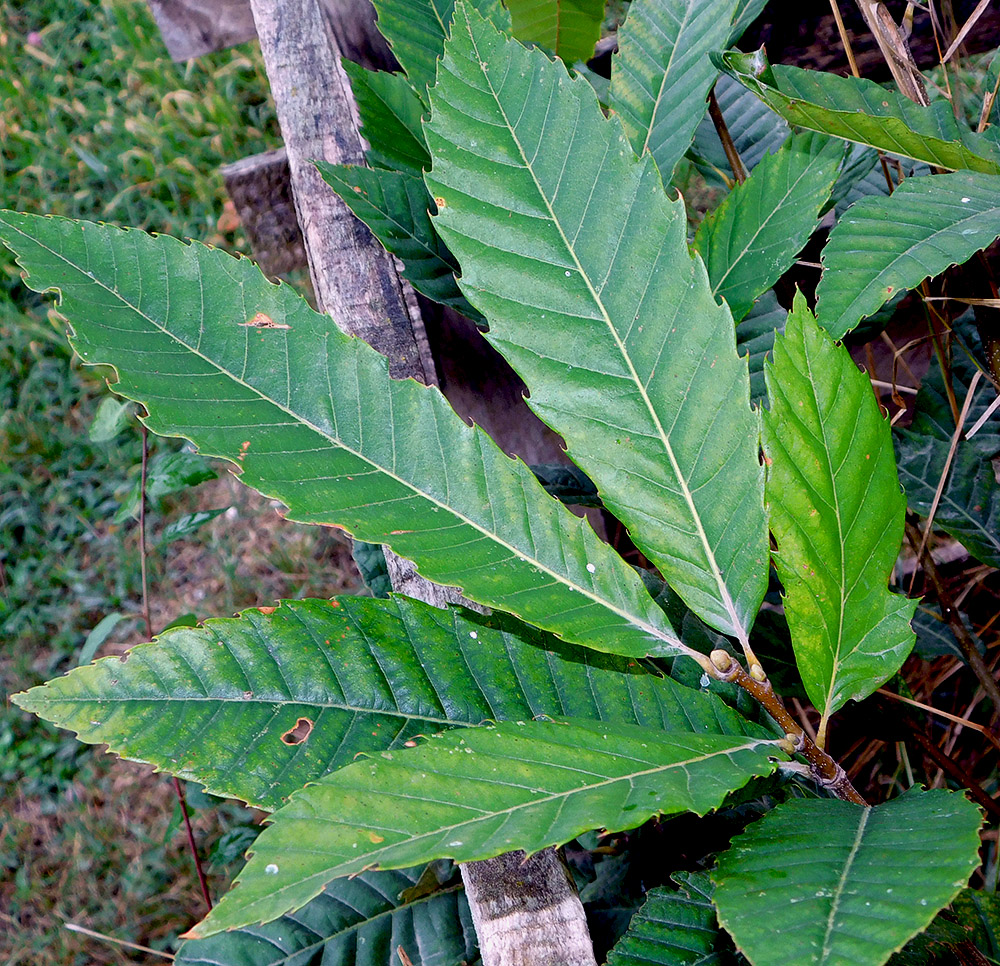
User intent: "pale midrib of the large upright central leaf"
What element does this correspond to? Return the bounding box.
[469,15,749,647]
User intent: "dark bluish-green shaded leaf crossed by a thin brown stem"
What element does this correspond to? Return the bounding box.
[689,74,792,185]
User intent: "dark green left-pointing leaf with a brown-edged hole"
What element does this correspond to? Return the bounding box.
[14,597,763,810]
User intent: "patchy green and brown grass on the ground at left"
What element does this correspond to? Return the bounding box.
[0,0,355,966]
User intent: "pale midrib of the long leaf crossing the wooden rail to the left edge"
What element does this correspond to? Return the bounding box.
[8,222,694,654]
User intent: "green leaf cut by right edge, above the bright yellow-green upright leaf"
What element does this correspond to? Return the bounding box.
[816,171,1000,339]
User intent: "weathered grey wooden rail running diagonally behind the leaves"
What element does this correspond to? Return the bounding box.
[246,0,596,966]
